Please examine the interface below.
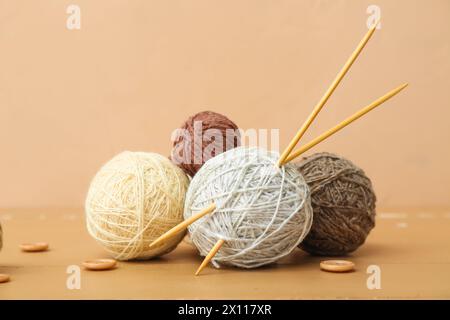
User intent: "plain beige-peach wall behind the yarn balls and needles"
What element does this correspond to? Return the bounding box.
[0,0,450,207]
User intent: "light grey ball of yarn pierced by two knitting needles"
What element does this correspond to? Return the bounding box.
[184,147,312,268]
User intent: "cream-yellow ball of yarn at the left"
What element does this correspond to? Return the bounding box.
[86,151,189,260]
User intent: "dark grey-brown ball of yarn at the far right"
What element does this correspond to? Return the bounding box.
[296,153,376,256]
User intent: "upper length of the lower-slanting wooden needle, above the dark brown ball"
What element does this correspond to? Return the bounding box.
[282,83,408,165]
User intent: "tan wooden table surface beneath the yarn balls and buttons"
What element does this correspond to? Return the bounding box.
[0,209,450,299]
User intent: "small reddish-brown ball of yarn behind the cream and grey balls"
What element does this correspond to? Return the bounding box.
[171,111,241,176]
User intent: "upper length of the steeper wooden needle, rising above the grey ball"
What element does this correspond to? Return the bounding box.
[277,20,379,167]
